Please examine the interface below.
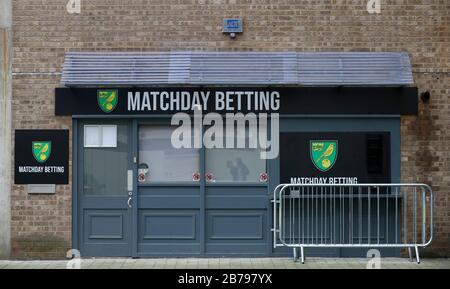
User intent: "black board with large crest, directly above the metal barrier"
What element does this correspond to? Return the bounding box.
[280,132,391,184]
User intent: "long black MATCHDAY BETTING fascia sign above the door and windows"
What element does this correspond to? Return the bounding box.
[55,86,417,116]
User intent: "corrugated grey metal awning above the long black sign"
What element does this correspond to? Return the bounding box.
[61,51,414,86]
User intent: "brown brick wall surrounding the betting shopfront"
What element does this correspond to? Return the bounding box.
[12,0,450,258]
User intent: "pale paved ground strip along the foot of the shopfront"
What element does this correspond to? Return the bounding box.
[0,258,450,270]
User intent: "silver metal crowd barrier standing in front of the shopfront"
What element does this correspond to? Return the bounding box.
[272,184,433,263]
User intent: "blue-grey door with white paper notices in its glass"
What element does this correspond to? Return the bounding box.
[76,120,133,256]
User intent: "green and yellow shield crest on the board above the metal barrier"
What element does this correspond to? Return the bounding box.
[309,140,338,172]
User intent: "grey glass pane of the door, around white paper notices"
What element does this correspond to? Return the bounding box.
[83,125,128,195]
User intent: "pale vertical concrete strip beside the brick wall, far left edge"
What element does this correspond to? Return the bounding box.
[0,0,12,258]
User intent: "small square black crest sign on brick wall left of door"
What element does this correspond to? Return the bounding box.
[14,129,69,184]
